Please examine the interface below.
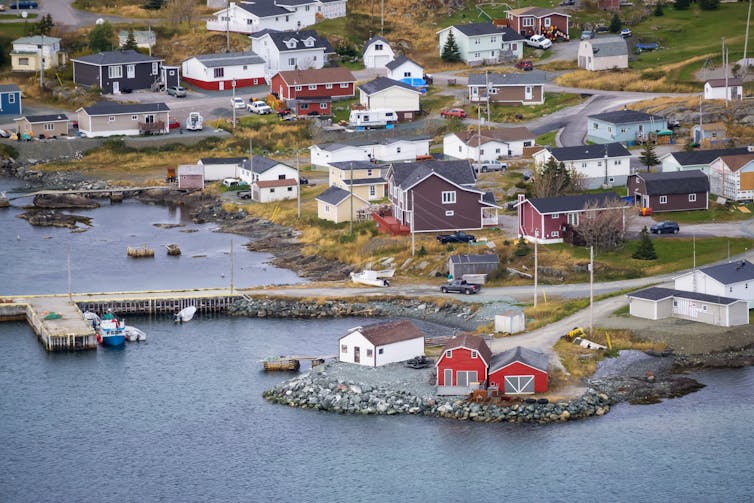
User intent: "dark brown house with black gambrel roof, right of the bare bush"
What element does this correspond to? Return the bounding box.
[626,169,709,213]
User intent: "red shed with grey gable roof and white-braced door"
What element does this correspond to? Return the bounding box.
[488,346,549,395]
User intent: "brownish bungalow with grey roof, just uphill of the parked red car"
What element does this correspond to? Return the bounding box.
[467,70,545,105]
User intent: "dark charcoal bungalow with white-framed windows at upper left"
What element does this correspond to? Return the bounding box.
[71,50,163,94]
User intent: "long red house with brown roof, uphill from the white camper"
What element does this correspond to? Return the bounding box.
[270,66,356,101]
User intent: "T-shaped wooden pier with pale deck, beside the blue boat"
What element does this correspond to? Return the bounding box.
[0,288,243,351]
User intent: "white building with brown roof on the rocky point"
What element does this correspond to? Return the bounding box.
[338,320,424,367]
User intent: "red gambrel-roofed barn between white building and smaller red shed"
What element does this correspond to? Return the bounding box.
[435,334,492,394]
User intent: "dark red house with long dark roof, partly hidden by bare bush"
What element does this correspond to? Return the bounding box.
[516,192,629,244]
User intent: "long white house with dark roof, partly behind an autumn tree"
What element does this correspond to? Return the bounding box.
[532,143,631,189]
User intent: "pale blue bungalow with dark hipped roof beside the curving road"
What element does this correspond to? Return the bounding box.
[586,110,670,146]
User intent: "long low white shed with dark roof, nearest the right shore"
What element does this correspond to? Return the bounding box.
[628,287,749,327]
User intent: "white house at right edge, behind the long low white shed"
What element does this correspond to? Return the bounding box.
[674,260,754,309]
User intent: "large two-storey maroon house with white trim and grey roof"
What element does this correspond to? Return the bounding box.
[386,160,500,232]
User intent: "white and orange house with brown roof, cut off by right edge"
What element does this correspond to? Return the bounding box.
[709,152,754,201]
